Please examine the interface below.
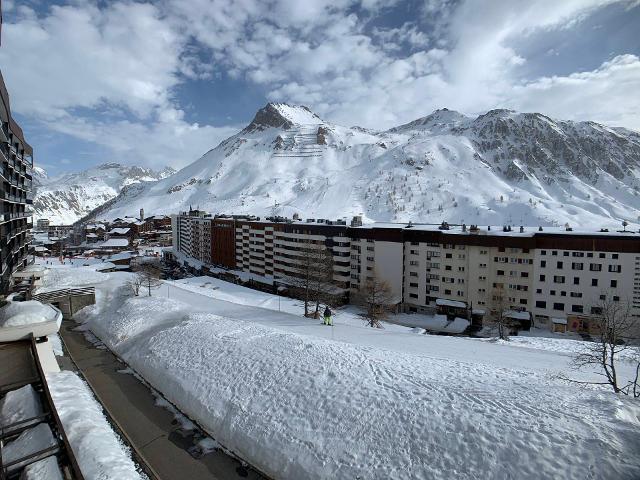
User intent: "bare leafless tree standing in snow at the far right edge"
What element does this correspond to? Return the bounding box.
[571,298,640,398]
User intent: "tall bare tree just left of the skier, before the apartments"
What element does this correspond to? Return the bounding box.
[287,240,336,317]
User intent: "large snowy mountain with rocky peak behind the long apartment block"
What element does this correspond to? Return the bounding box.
[85,104,640,226]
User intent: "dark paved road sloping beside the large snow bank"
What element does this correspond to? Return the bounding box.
[60,321,264,480]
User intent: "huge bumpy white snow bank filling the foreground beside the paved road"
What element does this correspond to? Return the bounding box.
[90,297,640,479]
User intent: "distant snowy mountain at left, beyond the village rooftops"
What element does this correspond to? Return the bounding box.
[33,163,175,225]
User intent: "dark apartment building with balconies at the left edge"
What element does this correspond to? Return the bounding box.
[0,69,33,293]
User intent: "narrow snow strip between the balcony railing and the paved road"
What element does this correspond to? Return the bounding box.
[47,371,142,480]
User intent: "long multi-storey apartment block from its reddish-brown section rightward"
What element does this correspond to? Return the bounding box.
[175,217,640,324]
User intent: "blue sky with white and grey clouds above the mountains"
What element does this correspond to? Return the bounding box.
[0,0,640,175]
